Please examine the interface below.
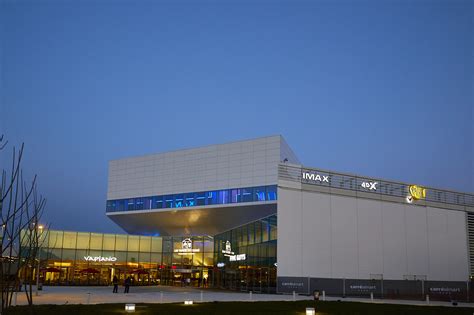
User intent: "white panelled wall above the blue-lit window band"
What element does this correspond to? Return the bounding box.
[107,136,293,200]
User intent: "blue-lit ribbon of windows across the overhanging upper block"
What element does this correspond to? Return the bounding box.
[106,185,277,212]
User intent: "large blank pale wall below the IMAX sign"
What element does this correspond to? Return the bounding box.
[278,187,468,281]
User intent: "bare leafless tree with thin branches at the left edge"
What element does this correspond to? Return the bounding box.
[0,136,46,313]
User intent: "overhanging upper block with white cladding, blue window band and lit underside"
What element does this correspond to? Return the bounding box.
[106,136,299,235]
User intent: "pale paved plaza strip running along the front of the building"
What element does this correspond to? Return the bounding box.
[10,286,474,308]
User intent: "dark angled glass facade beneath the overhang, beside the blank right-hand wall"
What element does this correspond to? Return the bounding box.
[213,214,277,293]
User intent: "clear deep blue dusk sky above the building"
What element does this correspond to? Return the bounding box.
[0,0,474,232]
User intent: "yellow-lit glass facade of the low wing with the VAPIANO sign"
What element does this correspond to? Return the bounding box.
[21,230,214,286]
